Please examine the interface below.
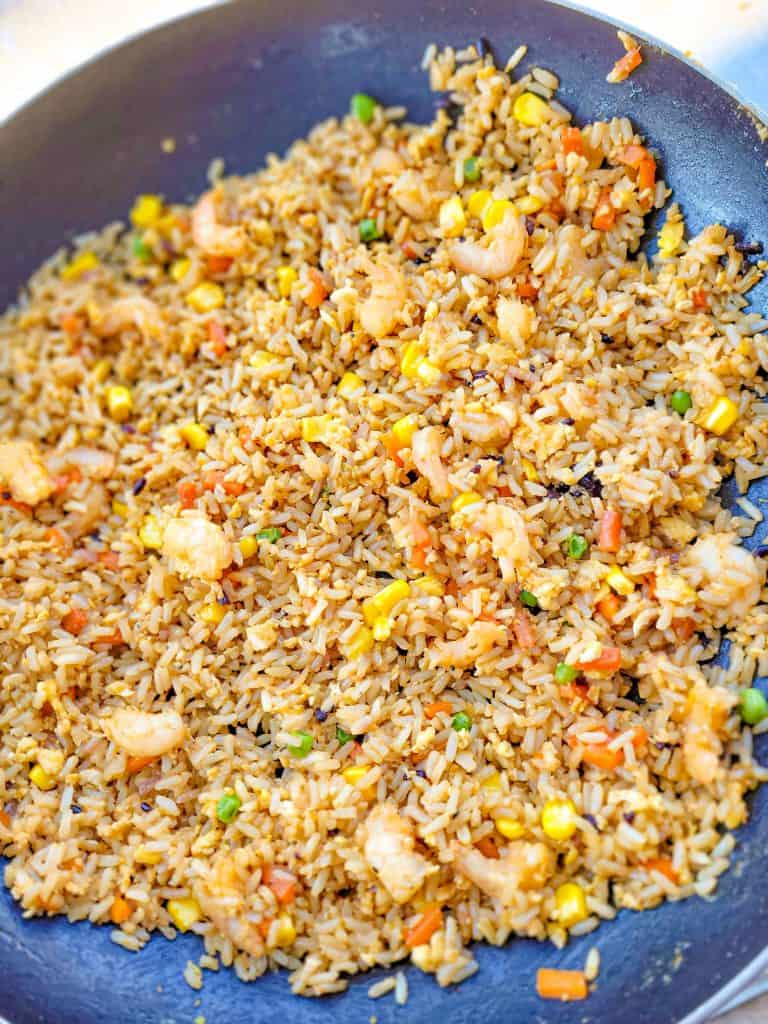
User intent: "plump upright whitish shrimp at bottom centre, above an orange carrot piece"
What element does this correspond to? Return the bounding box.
[364,803,437,903]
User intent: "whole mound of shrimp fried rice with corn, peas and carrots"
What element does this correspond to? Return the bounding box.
[0,44,768,994]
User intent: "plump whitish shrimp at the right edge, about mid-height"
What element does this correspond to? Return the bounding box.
[687,534,765,626]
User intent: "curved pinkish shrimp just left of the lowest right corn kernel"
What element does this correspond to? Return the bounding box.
[454,840,555,906]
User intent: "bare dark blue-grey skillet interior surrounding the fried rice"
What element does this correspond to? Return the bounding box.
[0,0,768,1024]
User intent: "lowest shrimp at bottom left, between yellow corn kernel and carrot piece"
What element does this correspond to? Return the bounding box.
[194,851,264,956]
